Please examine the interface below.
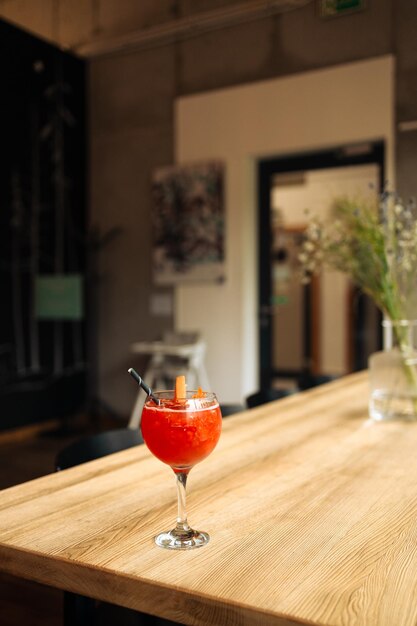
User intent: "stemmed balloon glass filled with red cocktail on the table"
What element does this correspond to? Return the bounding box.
[141,391,222,550]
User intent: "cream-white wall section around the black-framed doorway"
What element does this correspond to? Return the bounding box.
[175,56,394,402]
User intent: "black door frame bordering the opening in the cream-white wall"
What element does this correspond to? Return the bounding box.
[257,140,385,389]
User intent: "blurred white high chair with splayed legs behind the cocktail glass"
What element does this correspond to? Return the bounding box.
[128,332,210,429]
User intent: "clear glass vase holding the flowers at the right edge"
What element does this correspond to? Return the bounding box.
[369,320,417,422]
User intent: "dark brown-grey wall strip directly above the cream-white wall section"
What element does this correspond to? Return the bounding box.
[176,0,394,96]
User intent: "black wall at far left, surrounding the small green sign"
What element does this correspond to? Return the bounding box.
[0,21,86,429]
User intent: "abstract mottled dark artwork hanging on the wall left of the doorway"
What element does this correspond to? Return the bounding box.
[152,161,225,285]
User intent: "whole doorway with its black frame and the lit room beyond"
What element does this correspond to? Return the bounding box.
[258,141,384,389]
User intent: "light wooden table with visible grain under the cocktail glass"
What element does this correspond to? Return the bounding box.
[0,374,417,626]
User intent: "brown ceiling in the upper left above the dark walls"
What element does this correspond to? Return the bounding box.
[0,0,314,58]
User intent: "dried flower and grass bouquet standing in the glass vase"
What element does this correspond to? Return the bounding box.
[299,186,417,414]
